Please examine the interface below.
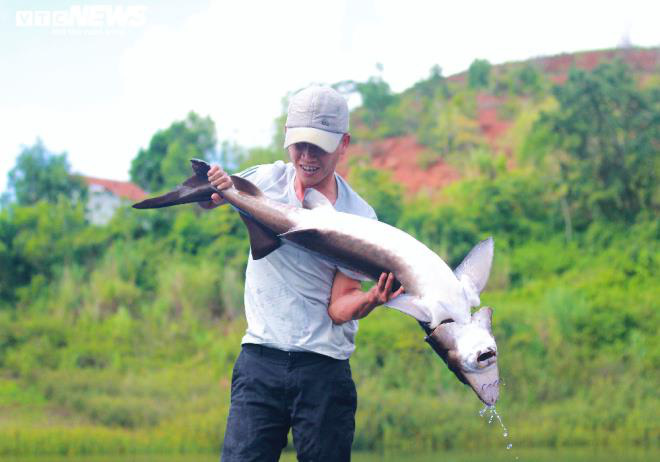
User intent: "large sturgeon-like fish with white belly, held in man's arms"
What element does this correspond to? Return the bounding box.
[133,159,499,405]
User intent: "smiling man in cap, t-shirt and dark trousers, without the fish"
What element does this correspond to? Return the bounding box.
[208,87,403,462]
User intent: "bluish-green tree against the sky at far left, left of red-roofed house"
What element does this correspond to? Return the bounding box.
[8,139,87,205]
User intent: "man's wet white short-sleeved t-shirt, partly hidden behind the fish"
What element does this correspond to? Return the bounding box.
[238,161,376,359]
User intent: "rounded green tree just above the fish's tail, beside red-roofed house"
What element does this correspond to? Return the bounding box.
[131,112,217,192]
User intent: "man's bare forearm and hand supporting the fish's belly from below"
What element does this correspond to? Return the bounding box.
[328,271,404,324]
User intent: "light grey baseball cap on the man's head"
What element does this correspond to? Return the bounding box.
[284,86,348,152]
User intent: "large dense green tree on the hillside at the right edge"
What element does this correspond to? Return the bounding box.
[524,63,660,226]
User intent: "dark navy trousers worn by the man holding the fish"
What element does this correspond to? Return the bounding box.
[222,344,357,462]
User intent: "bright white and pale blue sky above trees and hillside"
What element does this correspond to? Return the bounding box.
[0,0,660,191]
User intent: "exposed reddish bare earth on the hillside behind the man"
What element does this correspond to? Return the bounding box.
[339,48,660,194]
